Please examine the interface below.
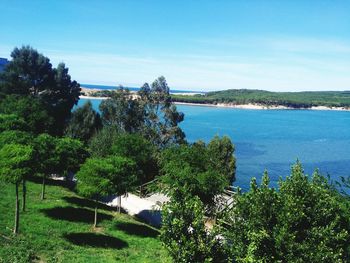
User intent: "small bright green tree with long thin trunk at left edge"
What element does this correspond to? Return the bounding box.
[0,144,32,234]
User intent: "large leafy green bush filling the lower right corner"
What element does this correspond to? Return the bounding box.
[224,162,350,262]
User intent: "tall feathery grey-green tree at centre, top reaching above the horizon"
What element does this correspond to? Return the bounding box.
[100,77,185,148]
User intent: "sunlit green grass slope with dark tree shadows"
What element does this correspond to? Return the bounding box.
[0,182,170,263]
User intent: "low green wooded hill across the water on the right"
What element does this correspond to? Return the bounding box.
[172,89,350,108]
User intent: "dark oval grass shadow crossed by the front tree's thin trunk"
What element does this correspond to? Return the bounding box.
[40,206,113,224]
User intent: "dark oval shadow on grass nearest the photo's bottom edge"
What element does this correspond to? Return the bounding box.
[63,233,128,249]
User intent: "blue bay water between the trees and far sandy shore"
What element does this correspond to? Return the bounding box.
[79,100,350,190]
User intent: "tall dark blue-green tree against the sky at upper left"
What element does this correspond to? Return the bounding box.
[0,46,80,135]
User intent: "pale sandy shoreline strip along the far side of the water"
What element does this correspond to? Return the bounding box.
[79,95,350,111]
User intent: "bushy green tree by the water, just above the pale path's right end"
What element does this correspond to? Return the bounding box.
[160,137,235,211]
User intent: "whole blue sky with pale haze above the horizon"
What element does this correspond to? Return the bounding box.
[0,0,350,91]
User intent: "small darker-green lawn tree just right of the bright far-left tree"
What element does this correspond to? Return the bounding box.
[33,134,59,200]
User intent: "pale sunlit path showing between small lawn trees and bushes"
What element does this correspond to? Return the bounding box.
[107,193,169,227]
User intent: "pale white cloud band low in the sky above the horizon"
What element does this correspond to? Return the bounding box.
[0,37,350,91]
